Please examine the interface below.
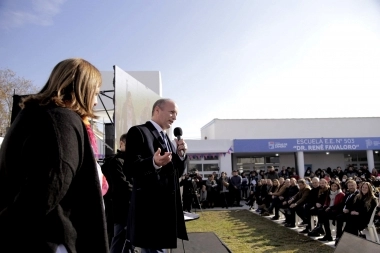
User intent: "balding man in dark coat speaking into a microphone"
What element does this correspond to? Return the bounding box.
[124,99,188,253]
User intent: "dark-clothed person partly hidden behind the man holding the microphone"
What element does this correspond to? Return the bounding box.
[108,134,134,253]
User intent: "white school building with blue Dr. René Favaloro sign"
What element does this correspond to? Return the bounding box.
[186,117,380,178]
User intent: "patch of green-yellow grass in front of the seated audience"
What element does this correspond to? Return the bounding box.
[186,210,334,253]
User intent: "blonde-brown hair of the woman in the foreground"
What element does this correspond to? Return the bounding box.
[20,58,102,118]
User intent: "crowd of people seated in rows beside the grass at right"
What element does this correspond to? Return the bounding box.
[247,166,380,245]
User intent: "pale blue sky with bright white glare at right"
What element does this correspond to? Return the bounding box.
[0,0,380,139]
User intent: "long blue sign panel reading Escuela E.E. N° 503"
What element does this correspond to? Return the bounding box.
[234,137,380,153]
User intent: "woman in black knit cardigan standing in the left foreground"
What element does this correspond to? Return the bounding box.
[0,58,109,253]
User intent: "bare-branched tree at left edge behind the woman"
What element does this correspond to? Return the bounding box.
[0,69,38,136]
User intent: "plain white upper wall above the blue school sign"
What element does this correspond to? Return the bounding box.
[201,117,380,139]
